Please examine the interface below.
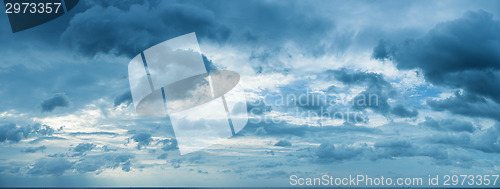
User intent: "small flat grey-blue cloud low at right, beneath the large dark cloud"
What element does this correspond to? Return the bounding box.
[420,117,476,133]
